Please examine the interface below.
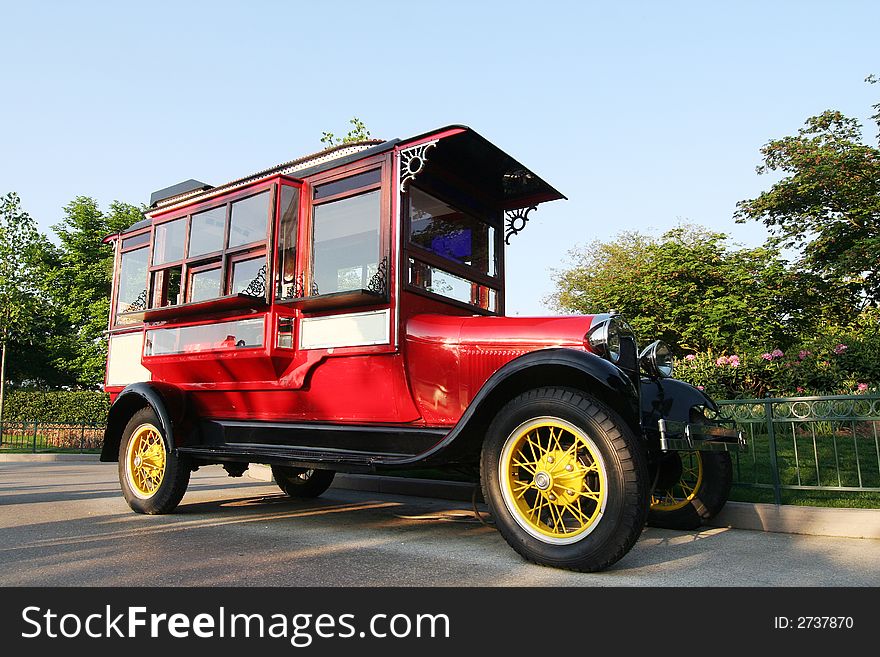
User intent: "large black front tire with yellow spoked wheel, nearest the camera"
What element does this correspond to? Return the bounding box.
[480,388,650,572]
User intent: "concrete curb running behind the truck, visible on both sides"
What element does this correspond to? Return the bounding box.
[6,454,880,539]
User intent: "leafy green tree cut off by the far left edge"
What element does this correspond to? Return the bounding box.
[0,192,45,420]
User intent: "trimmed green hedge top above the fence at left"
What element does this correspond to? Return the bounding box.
[3,390,110,426]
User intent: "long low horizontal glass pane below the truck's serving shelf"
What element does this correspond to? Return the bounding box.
[144,317,263,356]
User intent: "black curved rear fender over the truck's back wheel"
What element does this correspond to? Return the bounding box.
[101,381,187,461]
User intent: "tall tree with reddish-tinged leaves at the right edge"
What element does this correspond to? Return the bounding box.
[735,84,880,306]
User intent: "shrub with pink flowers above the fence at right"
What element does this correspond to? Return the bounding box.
[675,319,880,399]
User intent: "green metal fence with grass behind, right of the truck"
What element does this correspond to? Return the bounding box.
[718,395,880,504]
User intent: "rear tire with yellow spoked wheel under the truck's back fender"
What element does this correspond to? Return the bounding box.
[119,408,192,515]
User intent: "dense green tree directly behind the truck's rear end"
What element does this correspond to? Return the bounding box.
[51,196,143,387]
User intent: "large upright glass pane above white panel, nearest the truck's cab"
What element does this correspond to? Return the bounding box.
[312,190,379,294]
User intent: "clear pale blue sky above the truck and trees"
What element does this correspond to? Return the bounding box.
[0,0,880,314]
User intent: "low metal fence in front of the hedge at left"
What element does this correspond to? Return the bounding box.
[0,422,104,453]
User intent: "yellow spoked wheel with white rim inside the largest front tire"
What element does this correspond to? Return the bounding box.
[498,417,608,545]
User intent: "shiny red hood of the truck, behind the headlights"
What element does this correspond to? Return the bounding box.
[406,315,593,348]
